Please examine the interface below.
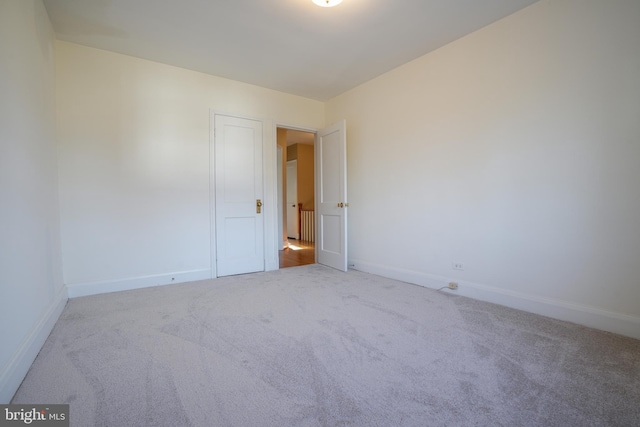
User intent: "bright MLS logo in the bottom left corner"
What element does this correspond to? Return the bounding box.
[0,405,69,427]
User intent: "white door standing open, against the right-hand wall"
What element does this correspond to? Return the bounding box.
[316,120,349,271]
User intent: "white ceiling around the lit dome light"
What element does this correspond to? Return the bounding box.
[44,0,537,101]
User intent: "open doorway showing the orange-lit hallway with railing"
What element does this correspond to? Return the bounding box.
[277,127,316,268]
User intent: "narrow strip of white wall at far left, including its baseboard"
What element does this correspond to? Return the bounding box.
[0,0,67,403]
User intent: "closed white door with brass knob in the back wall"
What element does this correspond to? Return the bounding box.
[214,114,264,277]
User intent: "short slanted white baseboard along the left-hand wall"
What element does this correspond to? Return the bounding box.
[0,286,68,404]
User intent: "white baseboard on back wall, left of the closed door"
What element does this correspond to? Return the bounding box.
[67,269,211,298]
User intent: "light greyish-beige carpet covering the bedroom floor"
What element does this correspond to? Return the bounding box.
[13,265,640,427]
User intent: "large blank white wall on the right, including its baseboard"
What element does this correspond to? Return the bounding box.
[326,0,640,338]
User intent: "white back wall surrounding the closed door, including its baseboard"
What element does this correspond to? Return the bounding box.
[57,41,324,296]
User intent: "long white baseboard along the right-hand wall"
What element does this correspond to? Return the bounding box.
[349,259,640,339]
